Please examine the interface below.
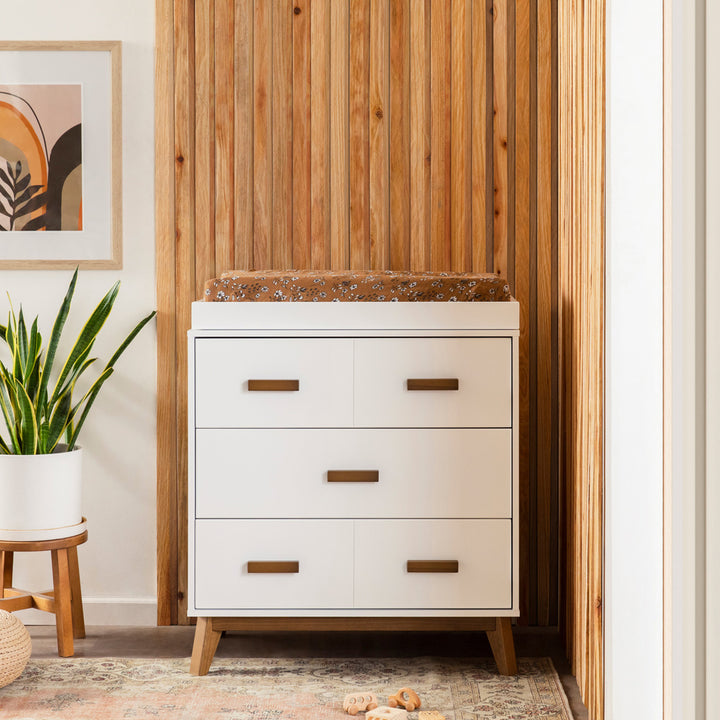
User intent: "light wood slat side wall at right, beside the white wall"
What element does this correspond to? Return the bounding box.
[558,0,605,720]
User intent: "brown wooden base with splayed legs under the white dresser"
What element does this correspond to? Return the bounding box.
[190,617,517,675]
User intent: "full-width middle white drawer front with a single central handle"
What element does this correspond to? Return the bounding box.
[196,429,512,518]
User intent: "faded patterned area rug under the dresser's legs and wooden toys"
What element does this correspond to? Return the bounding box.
[0,657,572,720]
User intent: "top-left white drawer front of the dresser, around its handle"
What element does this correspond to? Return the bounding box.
[195,338,353,428]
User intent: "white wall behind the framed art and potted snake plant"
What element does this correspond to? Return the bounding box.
[0,0,156,624]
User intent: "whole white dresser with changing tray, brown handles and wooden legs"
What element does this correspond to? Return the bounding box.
[188,302,519,674]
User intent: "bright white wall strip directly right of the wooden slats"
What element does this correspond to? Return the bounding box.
[605,0,663,720]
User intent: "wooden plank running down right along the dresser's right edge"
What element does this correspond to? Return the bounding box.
[513,0,536,622]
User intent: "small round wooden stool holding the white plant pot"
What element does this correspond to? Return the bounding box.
[0,530,87,657]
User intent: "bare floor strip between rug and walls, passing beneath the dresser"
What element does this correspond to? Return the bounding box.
[28,625,587,720]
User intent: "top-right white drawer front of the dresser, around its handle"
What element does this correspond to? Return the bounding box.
[355,338,512,427]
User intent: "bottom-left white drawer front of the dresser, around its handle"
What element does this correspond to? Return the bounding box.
[195,520,353,610]
